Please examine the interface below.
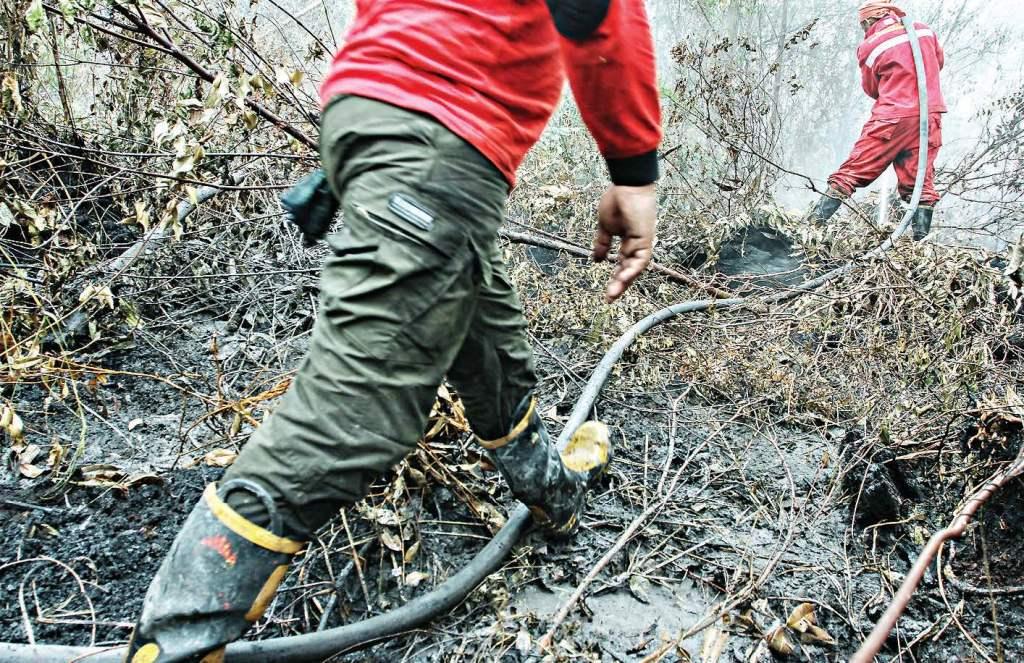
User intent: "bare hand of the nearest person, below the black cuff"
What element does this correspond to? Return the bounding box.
[593,184,657,303]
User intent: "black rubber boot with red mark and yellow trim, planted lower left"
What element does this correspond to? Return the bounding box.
[125,480,304,663]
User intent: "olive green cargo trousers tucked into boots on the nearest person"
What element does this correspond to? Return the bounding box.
[225,96,536,539]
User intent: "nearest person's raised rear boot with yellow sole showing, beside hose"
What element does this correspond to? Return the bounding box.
[480,397,611,537]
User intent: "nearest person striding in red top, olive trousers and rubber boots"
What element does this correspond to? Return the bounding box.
[126,0,660,663]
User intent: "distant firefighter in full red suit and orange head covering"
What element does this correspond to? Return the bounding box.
[813,0,946,240]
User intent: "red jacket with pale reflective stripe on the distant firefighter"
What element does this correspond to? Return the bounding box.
[857,15,946,119]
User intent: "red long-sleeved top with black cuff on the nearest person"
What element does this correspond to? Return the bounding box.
[319,0,662,185]
